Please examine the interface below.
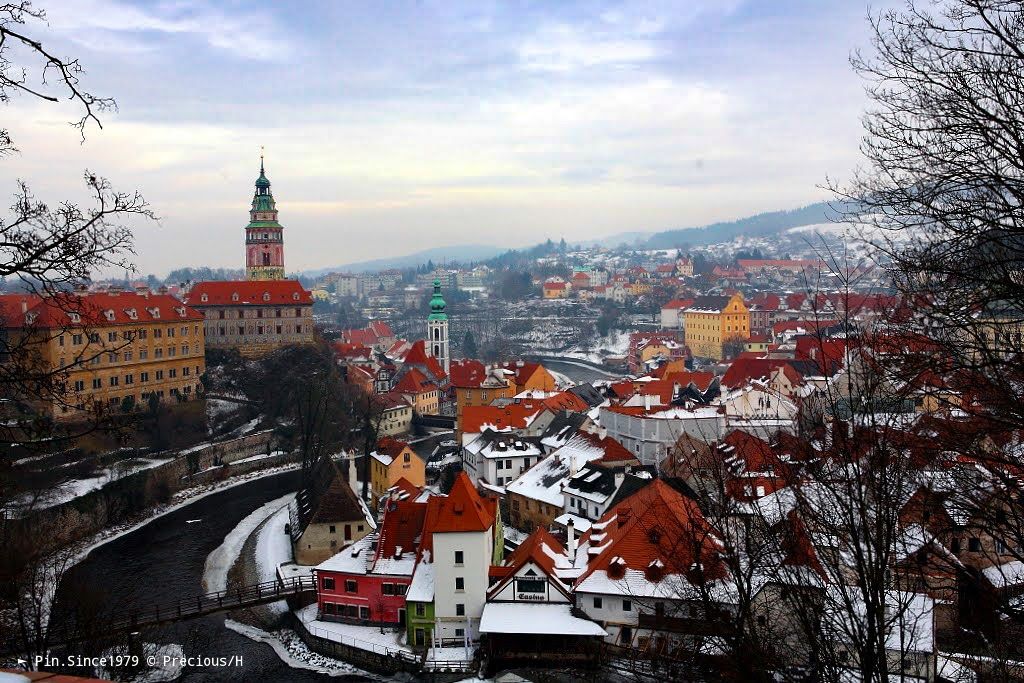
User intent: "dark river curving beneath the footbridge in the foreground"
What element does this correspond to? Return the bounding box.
[54,472,369,683]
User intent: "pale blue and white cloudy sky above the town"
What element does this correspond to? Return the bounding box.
[0,0,892,274]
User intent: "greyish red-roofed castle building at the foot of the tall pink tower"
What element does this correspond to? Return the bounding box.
[184,280,313,357]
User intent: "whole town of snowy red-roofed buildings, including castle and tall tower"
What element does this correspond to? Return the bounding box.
[0,159,1024,681]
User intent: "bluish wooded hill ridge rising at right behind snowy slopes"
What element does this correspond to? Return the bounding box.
[646,202,838,249]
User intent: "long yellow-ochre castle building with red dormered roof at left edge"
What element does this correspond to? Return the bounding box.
[0,289,206,420]
